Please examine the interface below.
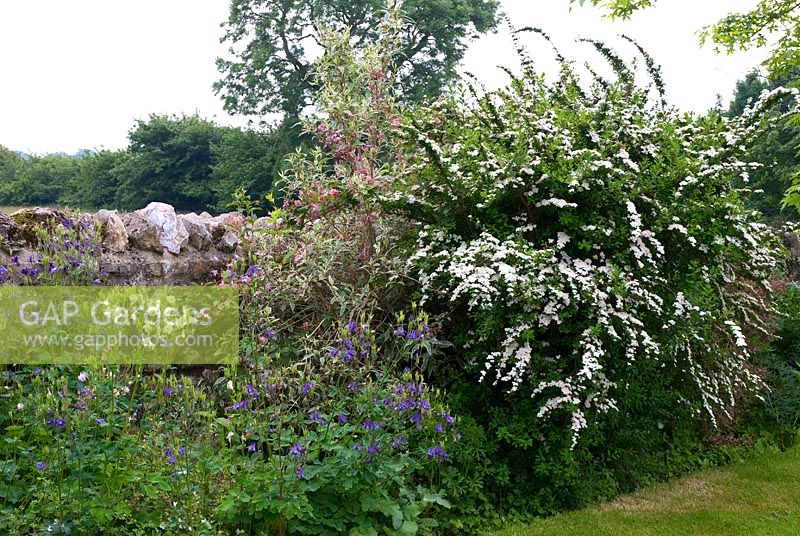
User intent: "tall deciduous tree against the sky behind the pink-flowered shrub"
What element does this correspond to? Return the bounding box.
[215,0,498,116]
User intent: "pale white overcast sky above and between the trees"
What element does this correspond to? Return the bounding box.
[0,0,765,154]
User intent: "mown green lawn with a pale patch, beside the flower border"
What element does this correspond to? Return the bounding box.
[498,448,800,536]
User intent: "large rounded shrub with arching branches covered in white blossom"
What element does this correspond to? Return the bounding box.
[389,35,796,447]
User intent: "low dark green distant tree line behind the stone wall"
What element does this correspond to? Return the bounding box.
[0,115,300,212]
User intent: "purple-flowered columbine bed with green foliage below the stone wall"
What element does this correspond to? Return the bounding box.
[0,336,457,535]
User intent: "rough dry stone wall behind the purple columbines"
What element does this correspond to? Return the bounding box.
[0,203,244,285]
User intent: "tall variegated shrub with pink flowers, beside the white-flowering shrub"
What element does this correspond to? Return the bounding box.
[220,7,410,344]
